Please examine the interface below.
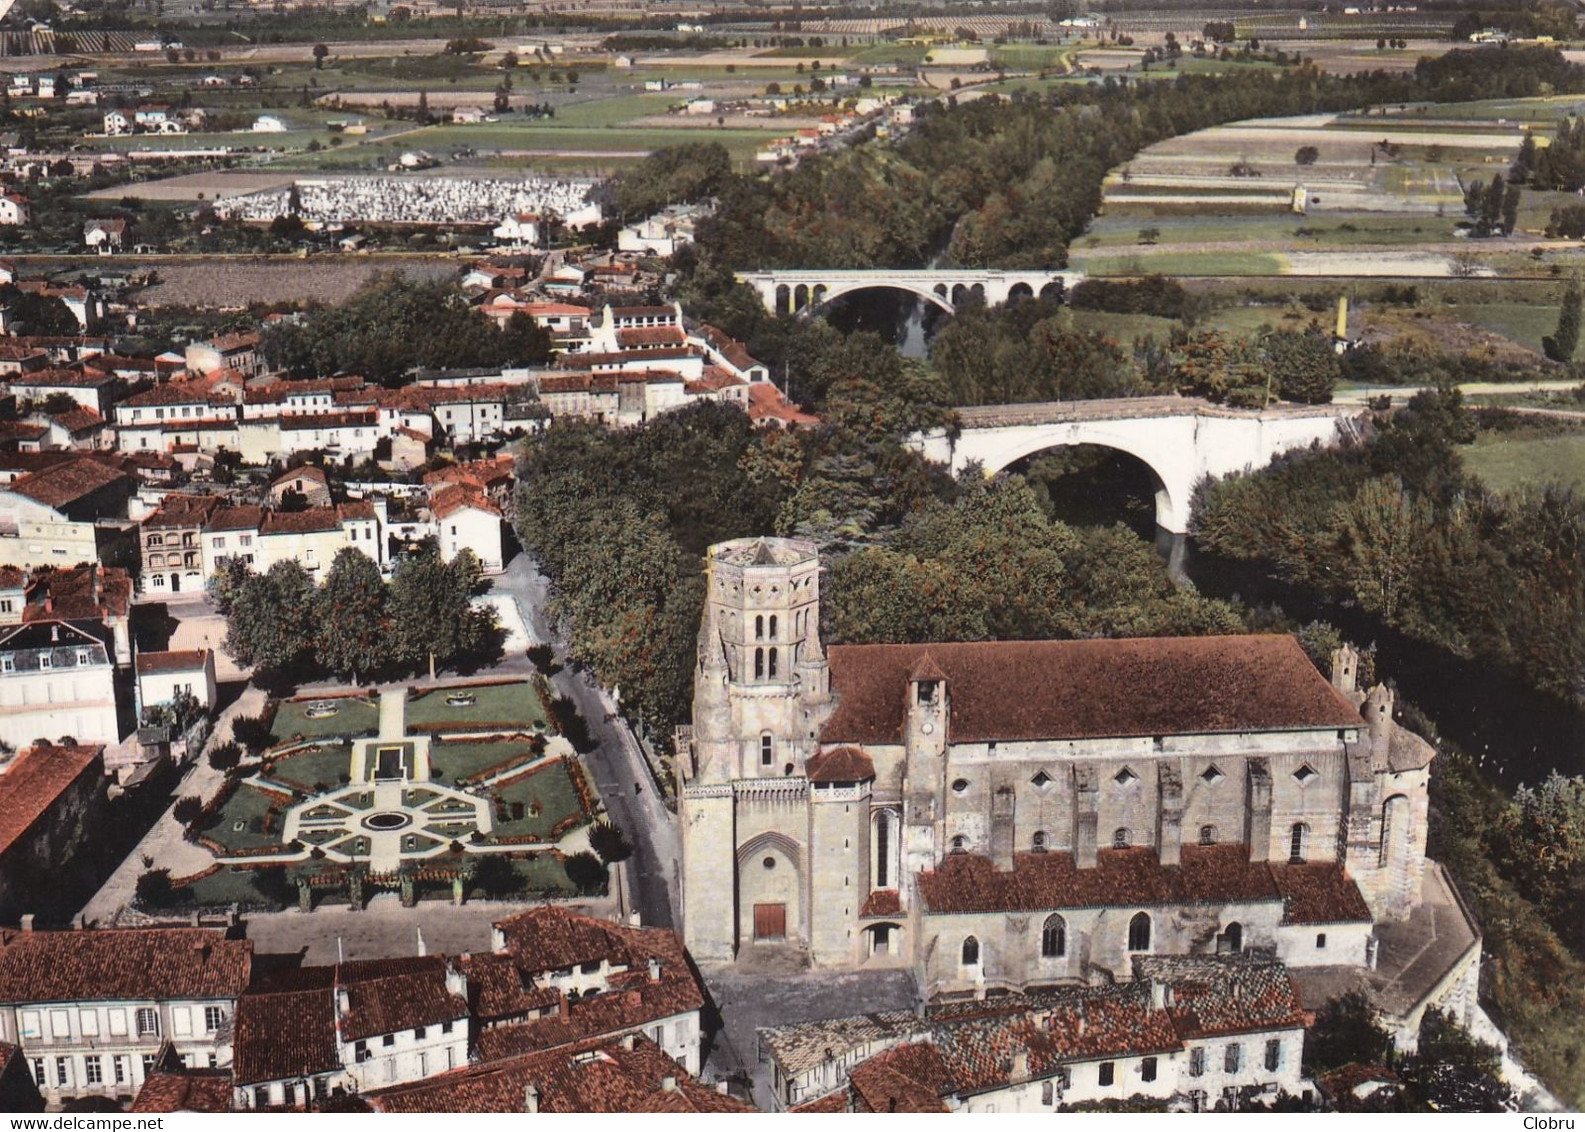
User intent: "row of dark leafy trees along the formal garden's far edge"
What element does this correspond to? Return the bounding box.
[211,547,501,683]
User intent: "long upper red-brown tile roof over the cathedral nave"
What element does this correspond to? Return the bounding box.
[821,636,1363,744]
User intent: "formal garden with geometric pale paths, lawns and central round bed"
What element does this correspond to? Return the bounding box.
[139,680,605,910]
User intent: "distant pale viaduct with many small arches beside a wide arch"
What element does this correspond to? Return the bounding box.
[737,268,1084,314]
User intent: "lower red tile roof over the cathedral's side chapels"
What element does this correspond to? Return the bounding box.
[918,845,1369,923]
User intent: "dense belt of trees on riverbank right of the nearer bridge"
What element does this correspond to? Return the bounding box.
[1194,390,1585,704]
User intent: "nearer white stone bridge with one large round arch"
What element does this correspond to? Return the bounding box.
[910,396,1363,534]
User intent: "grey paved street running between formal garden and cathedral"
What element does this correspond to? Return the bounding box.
[495,553,682,927]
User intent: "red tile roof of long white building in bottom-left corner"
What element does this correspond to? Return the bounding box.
[0,919,254,1002]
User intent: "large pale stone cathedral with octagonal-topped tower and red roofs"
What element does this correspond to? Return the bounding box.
[678,537,1433,994]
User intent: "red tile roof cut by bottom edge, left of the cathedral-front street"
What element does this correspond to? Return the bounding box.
[365,1037,754,1113]
